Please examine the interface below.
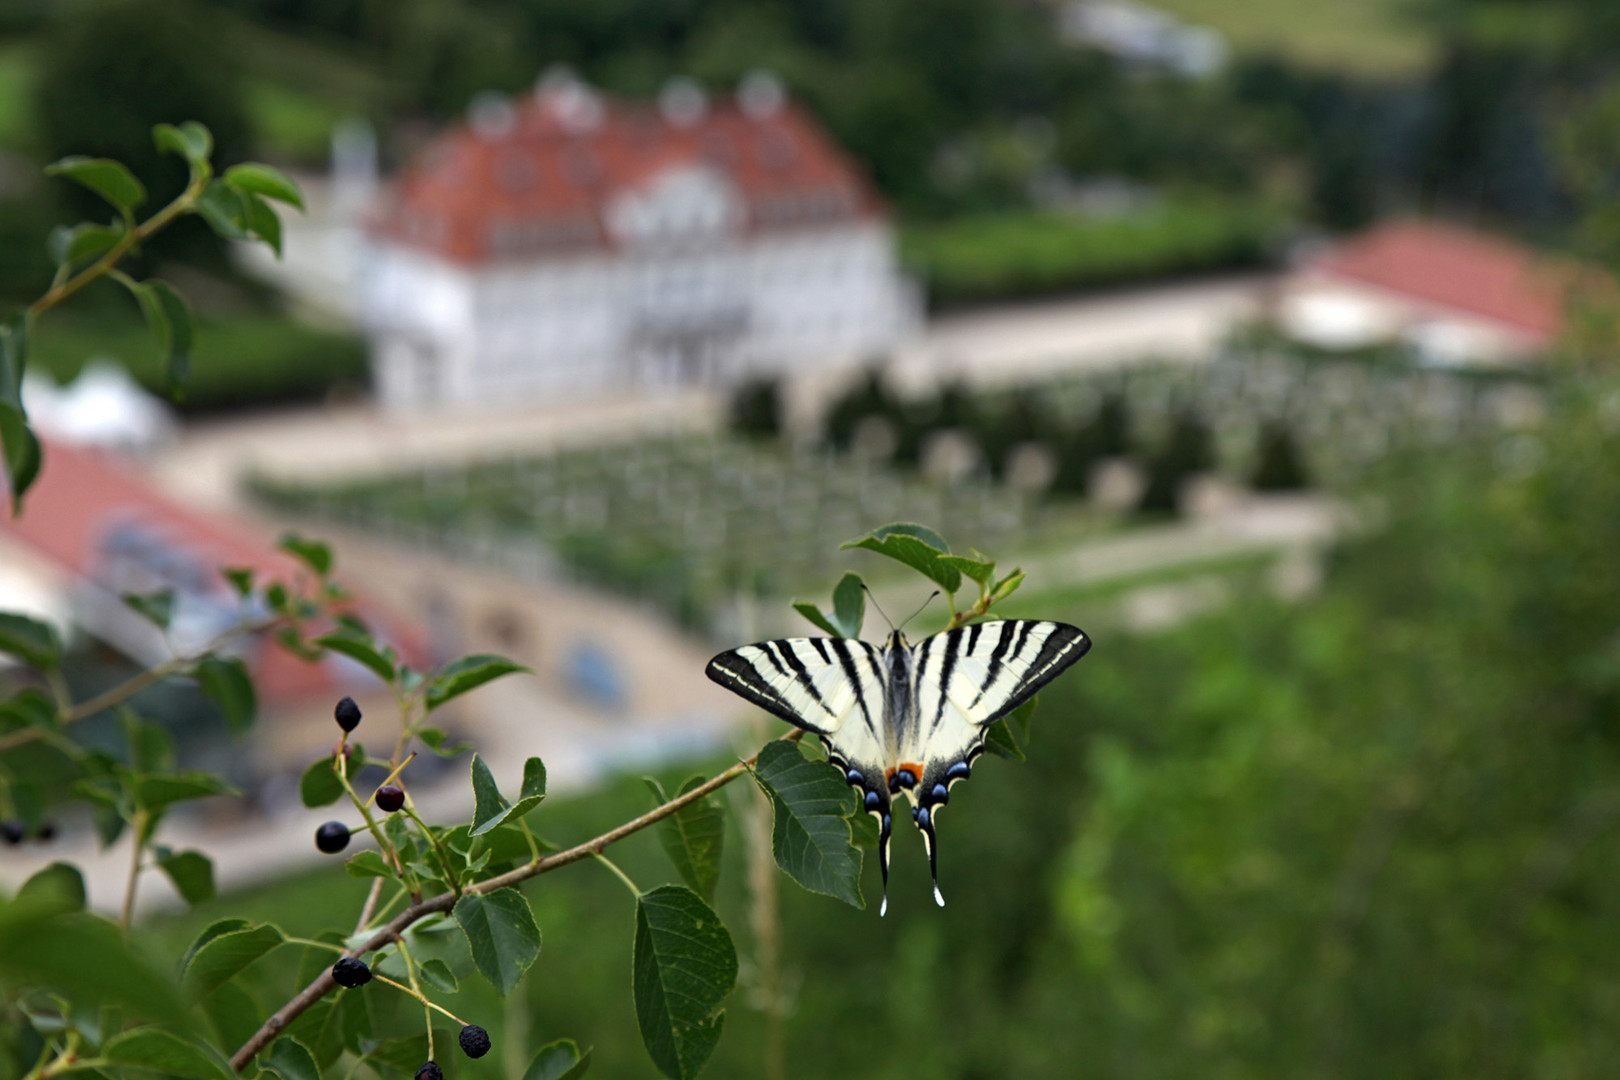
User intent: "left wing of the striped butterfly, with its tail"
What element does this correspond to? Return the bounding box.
[706,638,896,908]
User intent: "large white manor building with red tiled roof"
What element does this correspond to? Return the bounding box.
[360,76,920,410]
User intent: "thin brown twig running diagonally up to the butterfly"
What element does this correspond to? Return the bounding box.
[230,730,804,1072]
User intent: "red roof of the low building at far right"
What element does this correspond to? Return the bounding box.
[1312,220,1570,337]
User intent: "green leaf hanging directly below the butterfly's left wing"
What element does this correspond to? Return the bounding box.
[753,740,867,907]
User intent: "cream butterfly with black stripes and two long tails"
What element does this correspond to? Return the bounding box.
[705,619,1092,915]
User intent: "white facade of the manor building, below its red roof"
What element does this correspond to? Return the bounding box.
[360,120,922,410]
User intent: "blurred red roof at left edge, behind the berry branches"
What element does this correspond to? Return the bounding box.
[0,439,421,704]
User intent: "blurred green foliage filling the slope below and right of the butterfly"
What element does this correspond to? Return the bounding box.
[154,365,1620,1080]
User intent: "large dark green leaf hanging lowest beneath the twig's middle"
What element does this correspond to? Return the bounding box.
[633,886,737,1080]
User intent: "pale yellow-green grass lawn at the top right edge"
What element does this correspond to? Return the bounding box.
[1153,0,1435,76]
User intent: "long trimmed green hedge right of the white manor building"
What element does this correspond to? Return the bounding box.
[901,196,1281,306]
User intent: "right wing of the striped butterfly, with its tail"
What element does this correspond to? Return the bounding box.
[899,619,1092,907]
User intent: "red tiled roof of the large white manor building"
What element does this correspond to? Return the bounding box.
[373,91,883,264]
